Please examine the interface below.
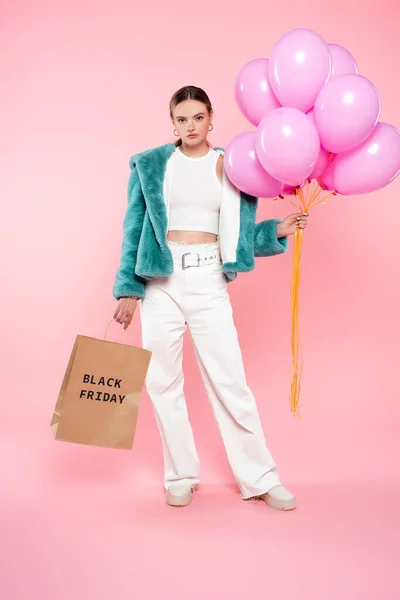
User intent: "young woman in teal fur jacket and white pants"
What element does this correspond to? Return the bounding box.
[113,86,308,510]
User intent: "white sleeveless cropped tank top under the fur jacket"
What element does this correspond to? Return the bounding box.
[166,146,222,235]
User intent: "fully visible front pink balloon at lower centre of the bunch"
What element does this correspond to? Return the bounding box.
[256,107,320,185]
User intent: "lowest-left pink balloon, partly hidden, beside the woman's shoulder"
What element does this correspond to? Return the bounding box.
[224,131,283,198]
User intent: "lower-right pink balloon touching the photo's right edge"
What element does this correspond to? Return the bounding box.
[333,123,400,195]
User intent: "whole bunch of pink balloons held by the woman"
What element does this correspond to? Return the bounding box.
[225,29,400,198]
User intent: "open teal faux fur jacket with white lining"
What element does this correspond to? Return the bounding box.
[113,143,288,300]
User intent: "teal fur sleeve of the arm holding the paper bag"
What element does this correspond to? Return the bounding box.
[113,167,146,300]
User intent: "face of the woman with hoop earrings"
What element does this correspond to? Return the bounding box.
[172,100,212,146]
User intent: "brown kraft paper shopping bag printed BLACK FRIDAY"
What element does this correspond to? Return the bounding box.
[50,335,151,450]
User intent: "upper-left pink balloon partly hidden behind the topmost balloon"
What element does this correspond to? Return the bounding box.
[235,58,280,127]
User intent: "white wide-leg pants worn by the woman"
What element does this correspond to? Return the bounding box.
[141,242,280,499]
